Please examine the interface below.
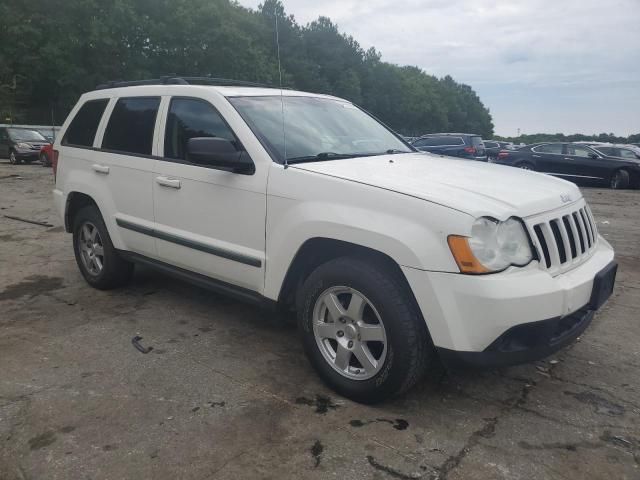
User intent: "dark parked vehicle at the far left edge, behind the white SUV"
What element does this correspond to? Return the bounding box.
[0,127,53,167]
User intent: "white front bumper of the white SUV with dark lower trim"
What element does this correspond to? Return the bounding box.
[403,237,615,366]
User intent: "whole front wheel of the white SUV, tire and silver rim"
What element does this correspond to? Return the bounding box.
[296,257,434,403]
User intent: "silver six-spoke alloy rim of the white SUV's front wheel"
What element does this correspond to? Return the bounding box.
[313,286,388,380]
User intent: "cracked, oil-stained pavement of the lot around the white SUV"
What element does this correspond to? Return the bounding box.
[0,160,640,480]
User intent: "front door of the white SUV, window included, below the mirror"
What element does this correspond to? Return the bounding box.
[153,97,267,292]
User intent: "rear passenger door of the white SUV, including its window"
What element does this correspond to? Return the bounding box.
[91,96,160,257]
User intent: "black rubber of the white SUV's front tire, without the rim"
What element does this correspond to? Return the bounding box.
[296,257,434,403]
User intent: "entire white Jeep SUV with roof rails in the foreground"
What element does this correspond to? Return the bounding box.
[54,79,616,402]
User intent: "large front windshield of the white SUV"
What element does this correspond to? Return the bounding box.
[229,95,413,163]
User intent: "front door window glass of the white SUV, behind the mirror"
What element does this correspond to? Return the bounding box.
[164,98,236,160]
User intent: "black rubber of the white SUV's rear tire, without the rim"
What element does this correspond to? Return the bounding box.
[73,205,133,290]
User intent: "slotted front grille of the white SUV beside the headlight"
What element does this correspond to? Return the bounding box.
[527,202,598,271]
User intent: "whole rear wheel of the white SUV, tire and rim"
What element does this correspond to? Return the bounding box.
[73,205,133,290]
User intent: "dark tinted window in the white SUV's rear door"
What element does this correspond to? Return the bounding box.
[102,97,160,155]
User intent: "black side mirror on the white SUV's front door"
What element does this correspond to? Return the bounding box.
[187,137,255,175]
